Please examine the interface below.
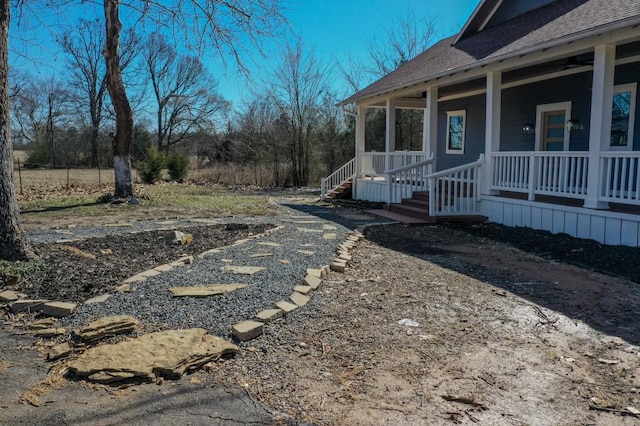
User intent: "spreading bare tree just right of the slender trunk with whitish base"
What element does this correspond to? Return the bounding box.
[142,33,229,150]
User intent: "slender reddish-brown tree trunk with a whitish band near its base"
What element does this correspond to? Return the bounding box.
[104,0,134,198]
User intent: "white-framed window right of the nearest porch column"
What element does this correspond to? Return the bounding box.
[609,83,637,150]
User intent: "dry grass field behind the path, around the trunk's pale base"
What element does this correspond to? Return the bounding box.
[15,169,274,225]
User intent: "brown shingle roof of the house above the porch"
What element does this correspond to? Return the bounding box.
[340,0,640,105]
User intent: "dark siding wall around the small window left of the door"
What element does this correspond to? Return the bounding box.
[436,94,486,170]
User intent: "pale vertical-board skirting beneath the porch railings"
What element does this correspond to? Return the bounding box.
[480,195,640,247]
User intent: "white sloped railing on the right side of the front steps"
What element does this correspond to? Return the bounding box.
[427,154,484,216]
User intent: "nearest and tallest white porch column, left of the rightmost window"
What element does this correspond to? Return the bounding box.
[584,44,616,209]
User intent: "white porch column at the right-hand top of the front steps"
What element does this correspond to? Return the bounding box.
[480,71,502,195]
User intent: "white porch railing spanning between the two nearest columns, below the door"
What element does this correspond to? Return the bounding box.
[491,151,589,200]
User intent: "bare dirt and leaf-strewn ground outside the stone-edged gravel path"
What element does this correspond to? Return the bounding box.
[0,204,640,425]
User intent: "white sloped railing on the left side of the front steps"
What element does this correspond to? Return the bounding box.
[386,153,435,202]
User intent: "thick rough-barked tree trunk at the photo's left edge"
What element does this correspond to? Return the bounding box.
[0,0,35,260]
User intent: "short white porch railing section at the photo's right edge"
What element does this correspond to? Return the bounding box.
[599,151,640,205]
